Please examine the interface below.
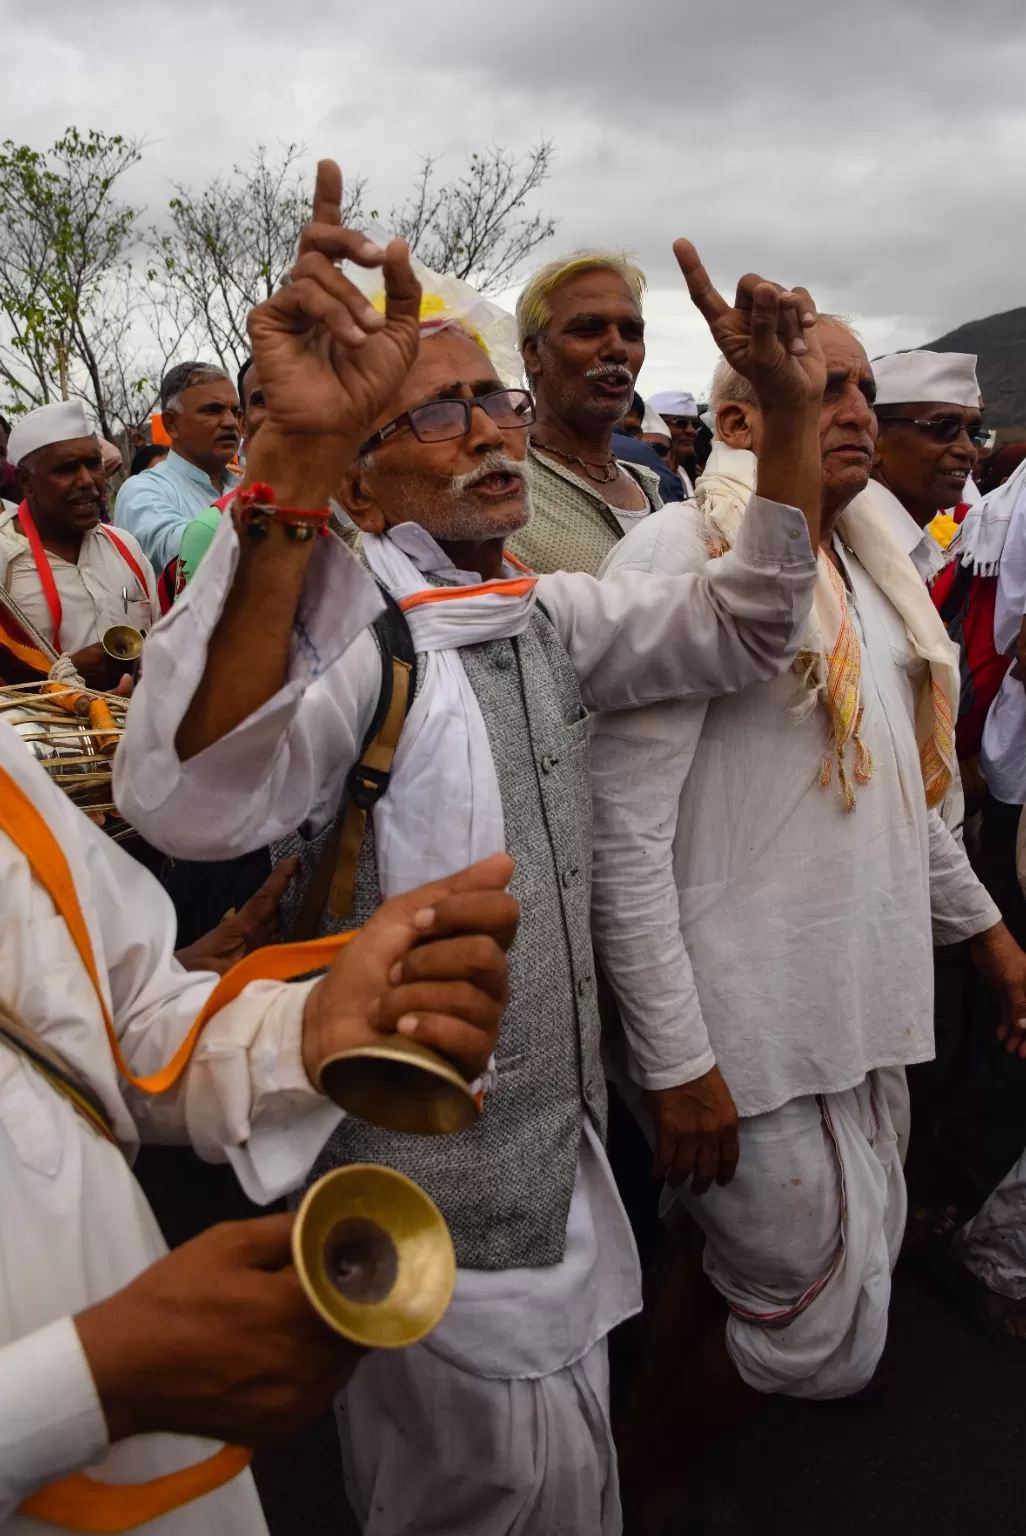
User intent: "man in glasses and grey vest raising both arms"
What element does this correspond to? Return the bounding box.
[117,161,823,1536]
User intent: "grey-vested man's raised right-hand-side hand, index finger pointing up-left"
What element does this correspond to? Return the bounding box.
[673,240,826,410]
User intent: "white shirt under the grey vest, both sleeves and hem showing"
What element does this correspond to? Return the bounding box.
[115,498,816,1378]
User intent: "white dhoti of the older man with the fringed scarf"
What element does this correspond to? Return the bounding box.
[676,1068,908,1398]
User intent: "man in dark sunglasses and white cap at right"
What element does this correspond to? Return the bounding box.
[872,352,988,581]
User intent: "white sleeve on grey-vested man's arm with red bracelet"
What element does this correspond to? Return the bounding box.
[114,518,382,859]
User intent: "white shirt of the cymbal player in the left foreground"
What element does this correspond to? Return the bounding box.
[0,723,339,1536]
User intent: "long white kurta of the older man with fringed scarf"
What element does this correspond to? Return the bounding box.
[593,504,1000,1115]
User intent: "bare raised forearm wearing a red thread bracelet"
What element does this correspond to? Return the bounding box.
[175,422,343,762]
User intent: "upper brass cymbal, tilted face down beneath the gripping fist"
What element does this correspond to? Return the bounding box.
[319,1035,481,1137]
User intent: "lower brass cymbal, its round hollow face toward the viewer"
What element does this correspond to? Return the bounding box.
[292,1163,456,1349]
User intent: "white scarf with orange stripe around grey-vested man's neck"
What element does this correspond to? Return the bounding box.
[362,522,536,895]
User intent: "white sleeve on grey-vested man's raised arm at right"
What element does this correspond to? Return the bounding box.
[538,496,816,710]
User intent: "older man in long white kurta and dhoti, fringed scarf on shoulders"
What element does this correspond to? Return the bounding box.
[593,301,1026,1398]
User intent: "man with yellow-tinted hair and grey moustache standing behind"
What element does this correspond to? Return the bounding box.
[508,250,662,576]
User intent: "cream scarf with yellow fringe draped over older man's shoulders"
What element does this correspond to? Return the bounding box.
[694,442,958,811]
